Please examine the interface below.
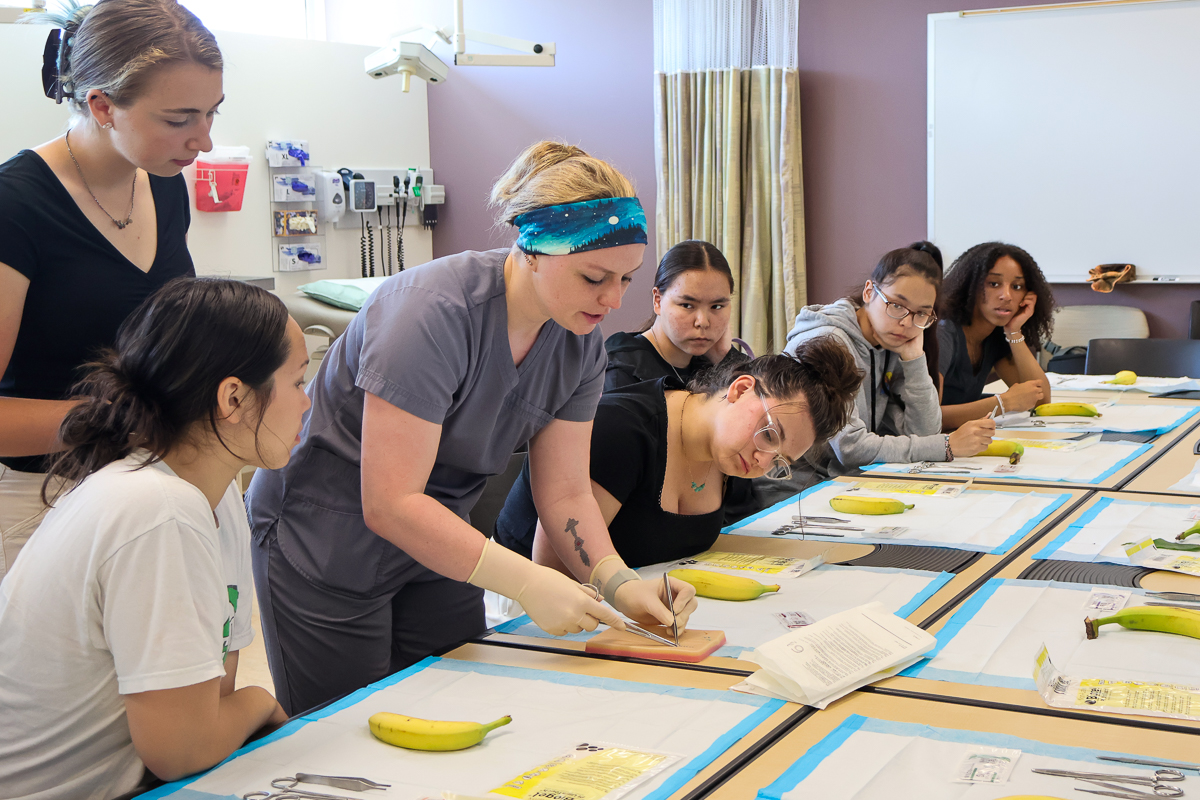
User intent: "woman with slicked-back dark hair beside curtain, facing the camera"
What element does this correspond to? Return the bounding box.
[604,239,750,392]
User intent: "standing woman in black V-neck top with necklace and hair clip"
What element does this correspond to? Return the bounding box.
[0,0,223,576]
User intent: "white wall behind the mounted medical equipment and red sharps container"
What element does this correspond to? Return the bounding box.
[0,24,432,294]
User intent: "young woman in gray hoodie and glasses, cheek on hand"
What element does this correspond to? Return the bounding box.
[786,242,996,476]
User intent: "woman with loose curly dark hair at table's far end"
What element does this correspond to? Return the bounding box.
[937,242,1054,431]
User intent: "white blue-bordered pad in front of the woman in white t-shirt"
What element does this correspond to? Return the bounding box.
[142,658,782,800]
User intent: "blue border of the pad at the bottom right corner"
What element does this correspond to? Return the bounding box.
[756,714,1171,800]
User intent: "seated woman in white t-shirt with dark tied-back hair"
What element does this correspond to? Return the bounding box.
[0,278,310,800]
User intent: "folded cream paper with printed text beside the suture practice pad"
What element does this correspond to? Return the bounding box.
[734,602,937,709]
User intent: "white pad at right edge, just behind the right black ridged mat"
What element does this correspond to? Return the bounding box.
[1033,498,1200,565]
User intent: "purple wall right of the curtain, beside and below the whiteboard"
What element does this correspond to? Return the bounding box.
[799,0,1200,337]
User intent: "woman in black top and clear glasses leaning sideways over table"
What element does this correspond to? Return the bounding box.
[533,337,863,567]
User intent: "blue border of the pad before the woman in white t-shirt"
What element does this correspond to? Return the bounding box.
[138,656,784,800]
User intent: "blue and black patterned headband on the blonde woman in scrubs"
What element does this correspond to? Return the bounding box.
[512,197,647,255]
